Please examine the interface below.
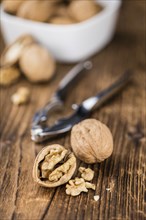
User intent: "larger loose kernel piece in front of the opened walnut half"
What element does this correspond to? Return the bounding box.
[66,177,95,196]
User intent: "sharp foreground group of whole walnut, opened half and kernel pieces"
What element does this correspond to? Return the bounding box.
[33,119,113,196]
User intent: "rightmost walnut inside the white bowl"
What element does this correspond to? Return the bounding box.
[68,1,101,22]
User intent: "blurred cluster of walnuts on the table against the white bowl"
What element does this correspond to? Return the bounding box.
[0,34,56,86]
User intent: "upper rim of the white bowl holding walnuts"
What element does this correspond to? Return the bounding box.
[0,0,122,31]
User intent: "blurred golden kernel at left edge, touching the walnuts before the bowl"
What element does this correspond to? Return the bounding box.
[0,66,20,86]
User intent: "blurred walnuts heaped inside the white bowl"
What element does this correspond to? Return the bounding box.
[3,0,102,24]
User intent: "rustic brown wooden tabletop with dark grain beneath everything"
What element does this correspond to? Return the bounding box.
[0,0,146,220]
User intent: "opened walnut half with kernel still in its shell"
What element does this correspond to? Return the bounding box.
[33,144,76,187]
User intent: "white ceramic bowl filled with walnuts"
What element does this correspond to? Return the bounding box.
[0,0,121,62]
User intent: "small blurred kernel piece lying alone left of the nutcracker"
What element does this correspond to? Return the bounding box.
[11,87,30,105]
